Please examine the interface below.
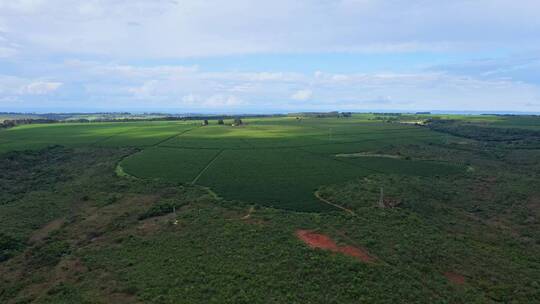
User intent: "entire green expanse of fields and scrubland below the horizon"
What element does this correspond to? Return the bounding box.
[0,114,540,303]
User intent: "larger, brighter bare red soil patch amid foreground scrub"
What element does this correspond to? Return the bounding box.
[296,230,375,263]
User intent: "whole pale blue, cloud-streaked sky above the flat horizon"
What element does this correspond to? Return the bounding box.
[0,0,540,113]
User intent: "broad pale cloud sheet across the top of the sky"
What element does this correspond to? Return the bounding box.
[0,0,540,58]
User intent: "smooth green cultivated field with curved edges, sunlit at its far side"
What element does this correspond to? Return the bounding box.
[0,115,464,211]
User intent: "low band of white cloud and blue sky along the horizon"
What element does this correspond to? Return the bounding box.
[0,61,540,112]
